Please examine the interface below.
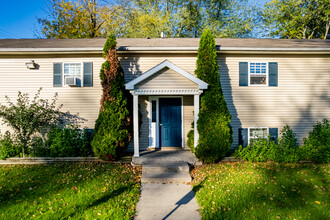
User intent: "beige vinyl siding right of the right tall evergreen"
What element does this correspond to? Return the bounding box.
[219,55,330,146]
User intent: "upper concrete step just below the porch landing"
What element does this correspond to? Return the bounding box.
[142,162,189,173]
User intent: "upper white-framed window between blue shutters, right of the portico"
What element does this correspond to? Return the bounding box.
[249,62,268,85]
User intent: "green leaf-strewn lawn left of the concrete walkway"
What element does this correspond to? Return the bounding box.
[0,163,141,219]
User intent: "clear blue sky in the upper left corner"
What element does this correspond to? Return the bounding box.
[0,0,47,39]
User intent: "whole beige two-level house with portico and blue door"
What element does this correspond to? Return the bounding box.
[0,38,330,156]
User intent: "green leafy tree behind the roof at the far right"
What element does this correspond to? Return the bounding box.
[263,0,330,39]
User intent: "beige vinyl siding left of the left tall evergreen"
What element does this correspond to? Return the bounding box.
[0,57,103,133]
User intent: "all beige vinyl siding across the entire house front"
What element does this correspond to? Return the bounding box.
[0,53,330,149]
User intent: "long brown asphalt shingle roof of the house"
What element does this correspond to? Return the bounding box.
[0,38,330,50]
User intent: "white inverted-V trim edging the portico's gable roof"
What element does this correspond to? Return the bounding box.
[125,60,208,90]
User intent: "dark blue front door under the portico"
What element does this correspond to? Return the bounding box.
[159,98,182,147]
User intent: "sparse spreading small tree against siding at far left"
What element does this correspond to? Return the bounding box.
[0,88,69,156]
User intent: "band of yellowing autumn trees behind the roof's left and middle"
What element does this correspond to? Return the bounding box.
[38,0,258,38]
